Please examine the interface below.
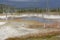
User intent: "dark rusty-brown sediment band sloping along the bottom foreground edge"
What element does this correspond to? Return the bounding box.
[6,31,60,40]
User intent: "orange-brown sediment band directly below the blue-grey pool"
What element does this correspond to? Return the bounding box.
[9,19,60,28]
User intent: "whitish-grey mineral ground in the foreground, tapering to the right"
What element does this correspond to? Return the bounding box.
[0,22,58,40]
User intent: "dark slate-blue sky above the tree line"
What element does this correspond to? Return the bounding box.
[0,0,60,8]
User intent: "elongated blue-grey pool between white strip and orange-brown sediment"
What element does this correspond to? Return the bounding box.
[21,16,54,23]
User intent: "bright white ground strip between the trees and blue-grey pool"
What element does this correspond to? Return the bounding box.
[0,12,60,19]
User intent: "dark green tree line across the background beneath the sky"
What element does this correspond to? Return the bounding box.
[0,8,60,13]
